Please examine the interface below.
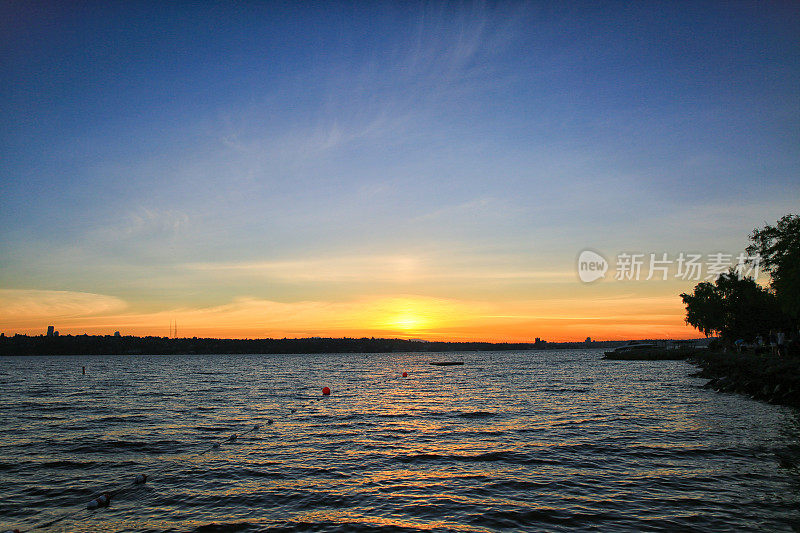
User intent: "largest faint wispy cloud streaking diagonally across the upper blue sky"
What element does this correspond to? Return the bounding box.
[209,4,525,170]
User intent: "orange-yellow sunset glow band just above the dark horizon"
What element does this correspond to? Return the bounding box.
[0,288,702,342]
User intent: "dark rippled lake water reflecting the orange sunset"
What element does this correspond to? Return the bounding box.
[0,350,800,532]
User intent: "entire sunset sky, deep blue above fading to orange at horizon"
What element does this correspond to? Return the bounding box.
[0,2,800,341]
